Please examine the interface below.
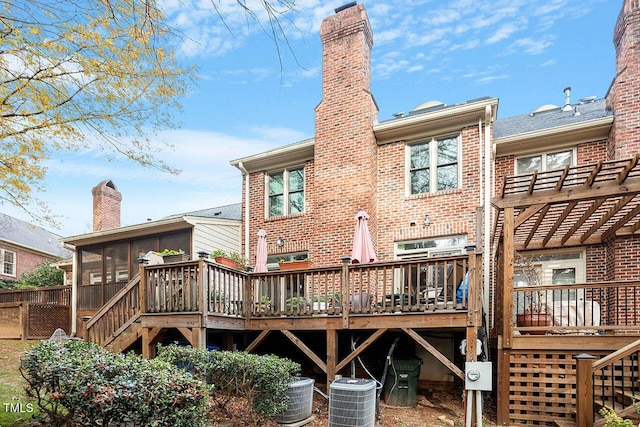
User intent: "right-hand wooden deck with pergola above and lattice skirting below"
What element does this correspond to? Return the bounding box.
[492,159,640,427]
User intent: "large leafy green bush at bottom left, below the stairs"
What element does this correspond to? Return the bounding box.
[20,340,206,427]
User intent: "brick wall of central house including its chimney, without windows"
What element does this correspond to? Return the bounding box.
[242,5,488,267]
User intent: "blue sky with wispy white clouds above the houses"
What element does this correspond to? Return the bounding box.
[0,0,622,236]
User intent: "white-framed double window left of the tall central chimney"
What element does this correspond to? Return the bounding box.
[267,167,304,217]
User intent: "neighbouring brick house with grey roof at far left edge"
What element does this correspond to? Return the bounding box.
[0,213,71,282]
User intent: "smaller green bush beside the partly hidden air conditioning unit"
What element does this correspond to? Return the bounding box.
[158,345,300,425]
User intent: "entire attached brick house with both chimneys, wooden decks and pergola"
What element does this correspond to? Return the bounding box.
[65,0,640,426]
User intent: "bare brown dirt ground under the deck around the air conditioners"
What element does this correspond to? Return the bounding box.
[210,390,496,427]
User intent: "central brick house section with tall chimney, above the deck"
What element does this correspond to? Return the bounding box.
[231,0,498,394]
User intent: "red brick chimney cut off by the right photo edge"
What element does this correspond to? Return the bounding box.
[607,0,640,159]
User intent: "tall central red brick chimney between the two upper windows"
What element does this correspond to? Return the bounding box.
[311,2,378,265]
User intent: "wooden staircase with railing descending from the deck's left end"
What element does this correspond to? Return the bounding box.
[86,274,142,351]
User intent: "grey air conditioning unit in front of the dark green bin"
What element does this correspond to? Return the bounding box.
[329,378,376,427]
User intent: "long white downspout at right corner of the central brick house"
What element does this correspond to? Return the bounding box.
[482,105,493,333]
